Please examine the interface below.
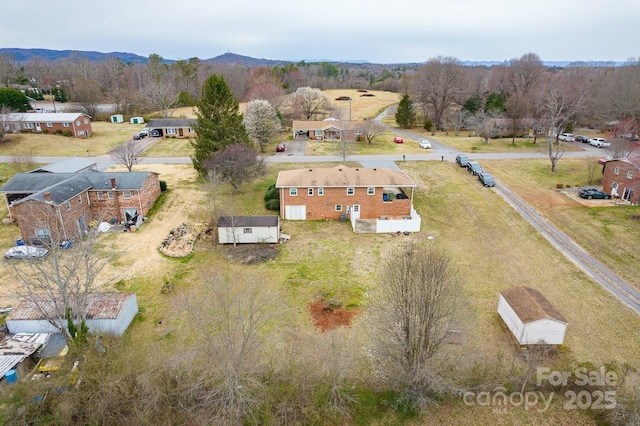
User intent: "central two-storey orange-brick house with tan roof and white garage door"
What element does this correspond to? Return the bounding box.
[276,166,418,232]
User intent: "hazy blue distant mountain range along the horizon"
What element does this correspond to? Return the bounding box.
[0,48,626,68]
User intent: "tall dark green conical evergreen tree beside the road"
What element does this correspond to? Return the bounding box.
[191,74,251,176]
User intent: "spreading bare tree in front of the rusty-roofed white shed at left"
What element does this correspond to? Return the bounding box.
[12,231,109,339]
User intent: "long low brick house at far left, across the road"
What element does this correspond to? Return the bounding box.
[0,112,93,138]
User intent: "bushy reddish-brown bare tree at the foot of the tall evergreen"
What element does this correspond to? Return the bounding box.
[204,143,265,192]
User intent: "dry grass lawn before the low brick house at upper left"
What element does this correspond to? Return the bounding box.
[0,121,144,157]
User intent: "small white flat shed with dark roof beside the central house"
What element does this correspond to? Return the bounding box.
[218,216,280,244]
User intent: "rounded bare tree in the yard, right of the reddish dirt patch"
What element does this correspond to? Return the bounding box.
[367,239,462,408]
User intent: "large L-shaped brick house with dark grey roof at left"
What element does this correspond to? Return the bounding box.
[0,169,160,244]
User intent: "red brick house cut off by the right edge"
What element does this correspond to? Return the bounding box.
[602,154,640,204]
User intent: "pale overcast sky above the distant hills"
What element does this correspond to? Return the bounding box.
[0,0,640,63]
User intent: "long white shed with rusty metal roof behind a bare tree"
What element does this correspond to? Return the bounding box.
[5,293,138,336]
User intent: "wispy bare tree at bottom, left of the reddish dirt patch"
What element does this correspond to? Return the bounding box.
[176,271,275,424]
